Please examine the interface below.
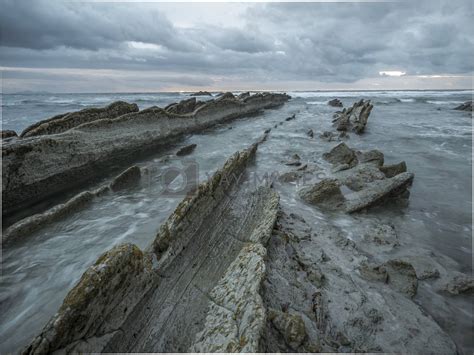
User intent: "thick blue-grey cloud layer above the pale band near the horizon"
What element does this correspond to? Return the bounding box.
[0,0,474,92]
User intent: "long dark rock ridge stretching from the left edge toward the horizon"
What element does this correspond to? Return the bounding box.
[2,94,289,216]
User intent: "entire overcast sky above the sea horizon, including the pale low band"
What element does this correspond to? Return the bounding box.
[0,0,474,93]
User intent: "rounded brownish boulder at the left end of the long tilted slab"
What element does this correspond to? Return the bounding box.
[298,179,344,209]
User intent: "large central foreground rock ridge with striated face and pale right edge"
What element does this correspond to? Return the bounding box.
[24,144,279,354]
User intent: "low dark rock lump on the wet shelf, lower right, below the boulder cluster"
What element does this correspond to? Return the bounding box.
[359,260,418,298]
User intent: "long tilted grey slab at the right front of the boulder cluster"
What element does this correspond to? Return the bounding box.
[345,173,415,213]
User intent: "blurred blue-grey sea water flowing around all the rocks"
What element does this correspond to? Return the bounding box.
[0,91,474,353]
